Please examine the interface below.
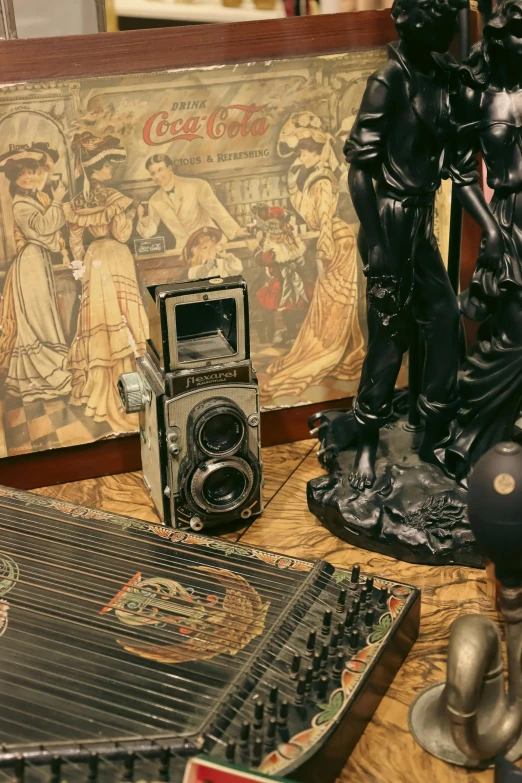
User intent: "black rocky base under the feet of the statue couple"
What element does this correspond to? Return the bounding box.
[307,412,484,568]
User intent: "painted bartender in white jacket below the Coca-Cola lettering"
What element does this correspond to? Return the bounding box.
[137,155,247,249]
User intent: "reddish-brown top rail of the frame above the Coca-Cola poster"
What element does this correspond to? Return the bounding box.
[0,10,397,84]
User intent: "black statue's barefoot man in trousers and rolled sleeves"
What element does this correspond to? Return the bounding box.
[345,0,500,491]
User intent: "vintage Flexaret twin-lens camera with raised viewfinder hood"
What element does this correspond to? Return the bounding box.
[118,277,262,530]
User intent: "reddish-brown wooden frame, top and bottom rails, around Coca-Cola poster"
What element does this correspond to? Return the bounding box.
[0,10,397,489]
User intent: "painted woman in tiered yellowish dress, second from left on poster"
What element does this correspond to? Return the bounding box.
[64,133,148,432]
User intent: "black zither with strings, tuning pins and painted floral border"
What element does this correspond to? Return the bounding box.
[0,488,420,783]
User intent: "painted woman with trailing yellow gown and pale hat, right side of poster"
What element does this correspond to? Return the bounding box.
[264,112,364,398]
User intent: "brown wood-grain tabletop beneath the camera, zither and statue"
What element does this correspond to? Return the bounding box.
[35,440,493,783]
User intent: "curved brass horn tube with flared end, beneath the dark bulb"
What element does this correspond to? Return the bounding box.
[409,587,522,768]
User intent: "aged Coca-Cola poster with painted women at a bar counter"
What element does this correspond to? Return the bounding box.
[0,49,449,457]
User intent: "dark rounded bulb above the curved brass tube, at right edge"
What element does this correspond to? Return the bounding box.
[468,443,522,581]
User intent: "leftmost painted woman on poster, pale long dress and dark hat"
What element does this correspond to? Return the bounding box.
[0,144,71,402]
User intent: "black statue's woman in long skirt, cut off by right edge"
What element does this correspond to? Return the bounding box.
[446,0,522,481]
